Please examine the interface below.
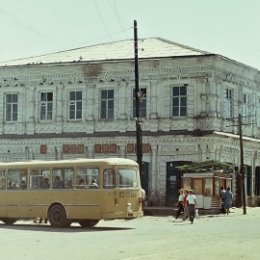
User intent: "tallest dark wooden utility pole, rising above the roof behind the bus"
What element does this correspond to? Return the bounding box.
[134,20,143,178]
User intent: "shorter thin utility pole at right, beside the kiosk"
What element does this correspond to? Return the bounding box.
[238,114,246,215]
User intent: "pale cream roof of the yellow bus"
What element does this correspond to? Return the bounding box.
[0,158,138,168]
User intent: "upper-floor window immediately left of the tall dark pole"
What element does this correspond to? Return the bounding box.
[100,89,114,119]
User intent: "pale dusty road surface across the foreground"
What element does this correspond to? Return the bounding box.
[0,208,260,260]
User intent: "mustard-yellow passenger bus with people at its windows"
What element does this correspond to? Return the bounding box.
[0,158,144,227]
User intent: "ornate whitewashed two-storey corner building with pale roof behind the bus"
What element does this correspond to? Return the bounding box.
[0,38,260,205]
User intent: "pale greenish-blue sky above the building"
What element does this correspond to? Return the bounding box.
[0,0,260,70]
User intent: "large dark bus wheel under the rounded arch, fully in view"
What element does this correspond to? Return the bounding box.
[48,204,69,228]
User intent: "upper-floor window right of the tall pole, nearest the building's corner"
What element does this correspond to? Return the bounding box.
[172,85,187,117]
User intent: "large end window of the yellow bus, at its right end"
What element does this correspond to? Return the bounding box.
[117,168,139,188]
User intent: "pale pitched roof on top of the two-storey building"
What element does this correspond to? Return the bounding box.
[0,38,211,66]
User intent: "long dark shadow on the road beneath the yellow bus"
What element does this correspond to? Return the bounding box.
[0,224,133,233]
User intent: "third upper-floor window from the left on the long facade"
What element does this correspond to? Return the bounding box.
[69,91,82,120]
